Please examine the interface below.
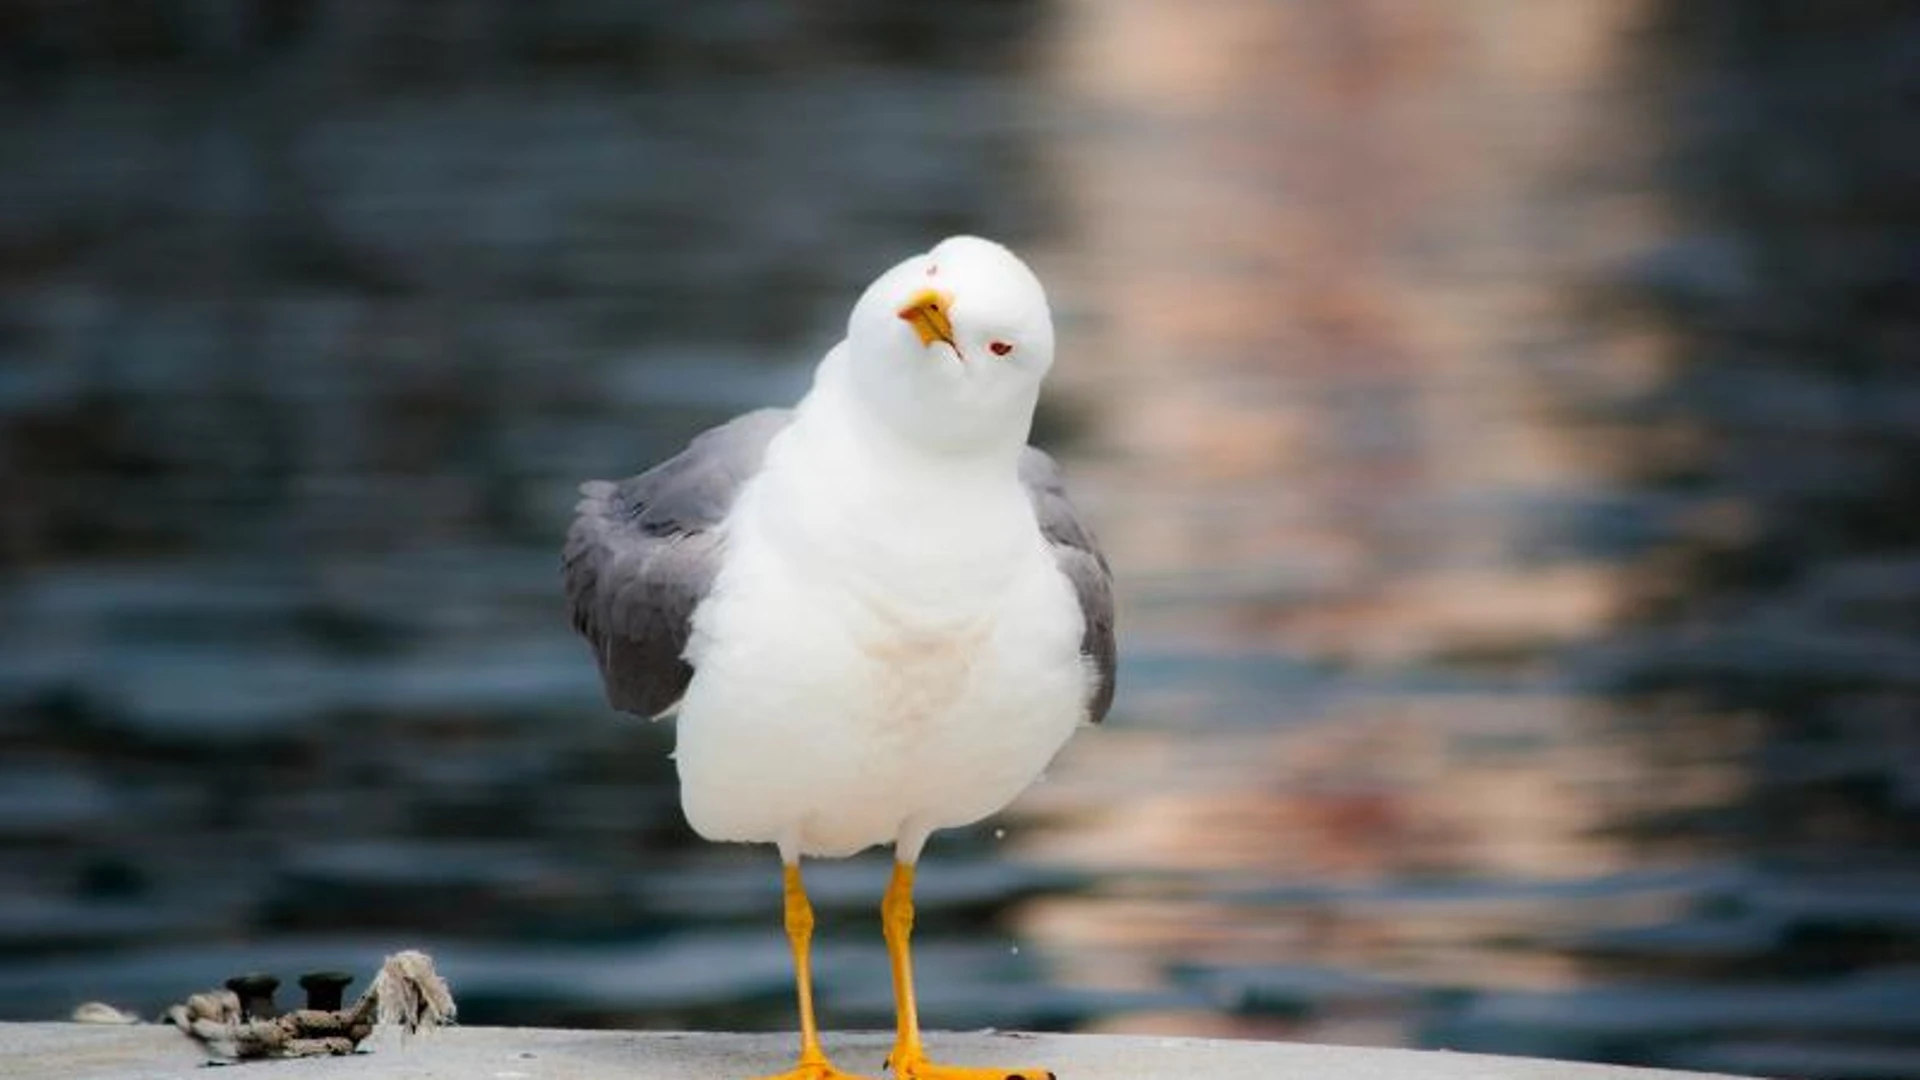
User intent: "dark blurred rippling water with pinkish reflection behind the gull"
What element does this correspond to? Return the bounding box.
[0,0,1920,1076]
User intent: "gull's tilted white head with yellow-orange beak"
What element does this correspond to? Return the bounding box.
[847,236,1054,450]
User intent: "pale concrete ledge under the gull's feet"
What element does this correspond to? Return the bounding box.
[0,1024,1751,1080]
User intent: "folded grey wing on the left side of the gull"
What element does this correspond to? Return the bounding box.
[563,409,793,717]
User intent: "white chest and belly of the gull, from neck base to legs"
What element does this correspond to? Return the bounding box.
[676,426,1089,853]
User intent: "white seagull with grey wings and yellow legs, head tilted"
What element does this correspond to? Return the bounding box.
[564,236,1116,1080]
